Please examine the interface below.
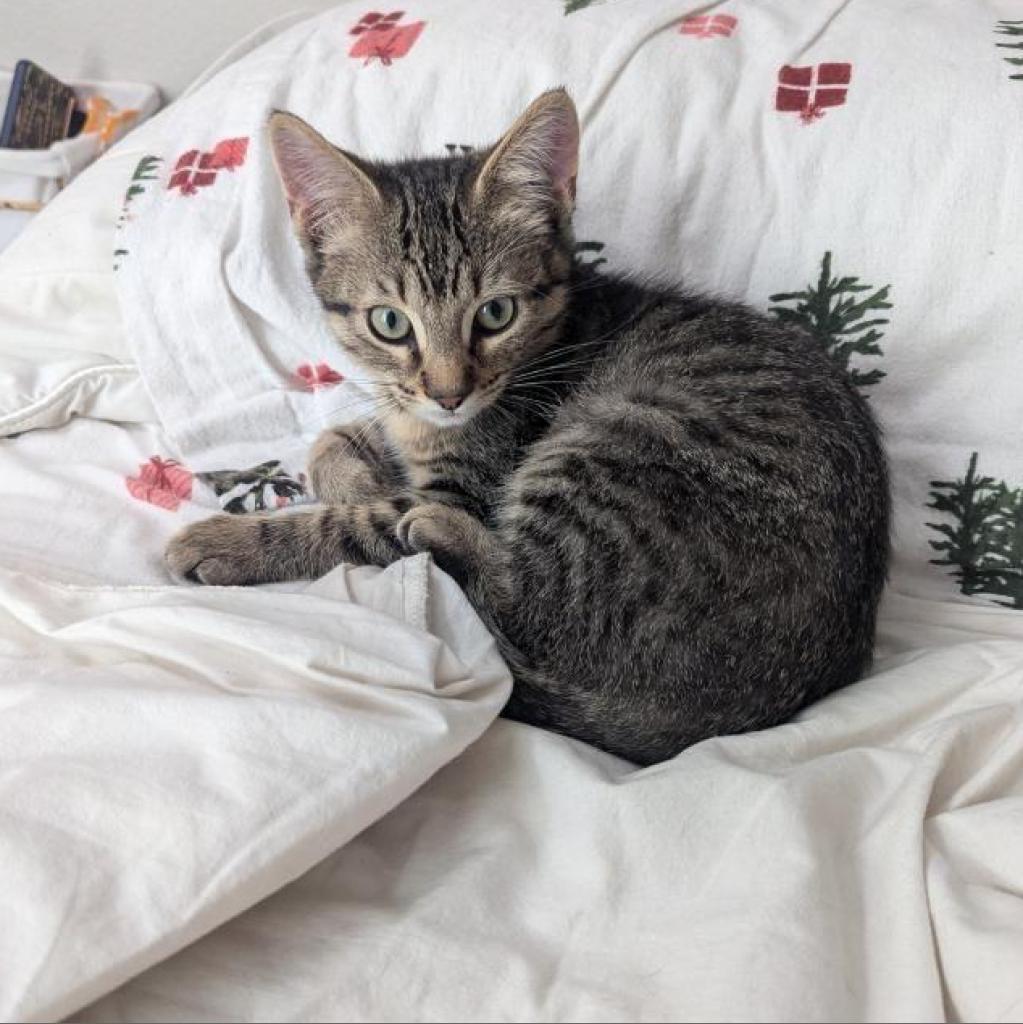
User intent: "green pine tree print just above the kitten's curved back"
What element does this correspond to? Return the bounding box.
[769,252,892,388]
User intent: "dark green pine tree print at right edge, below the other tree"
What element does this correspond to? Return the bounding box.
[927,452,1023,608]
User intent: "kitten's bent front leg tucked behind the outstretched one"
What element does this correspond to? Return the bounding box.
[308,423,402,505]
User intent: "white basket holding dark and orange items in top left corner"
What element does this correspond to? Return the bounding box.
[0,70,160,249]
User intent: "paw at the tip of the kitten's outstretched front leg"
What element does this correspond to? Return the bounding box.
[164,515,263,587]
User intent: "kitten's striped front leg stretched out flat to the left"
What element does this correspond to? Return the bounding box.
[165,499,409,587]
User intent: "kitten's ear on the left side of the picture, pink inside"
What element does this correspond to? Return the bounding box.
[267,111,380,245]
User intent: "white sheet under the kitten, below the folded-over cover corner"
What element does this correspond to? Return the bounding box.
[78,598,1023,1021]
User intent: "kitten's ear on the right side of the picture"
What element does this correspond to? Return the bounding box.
[475,89,579,214]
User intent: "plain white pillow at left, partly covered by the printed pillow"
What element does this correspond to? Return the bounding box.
[0,11,303,437]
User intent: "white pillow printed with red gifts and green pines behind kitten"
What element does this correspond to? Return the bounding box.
[4,0,1023,607]
